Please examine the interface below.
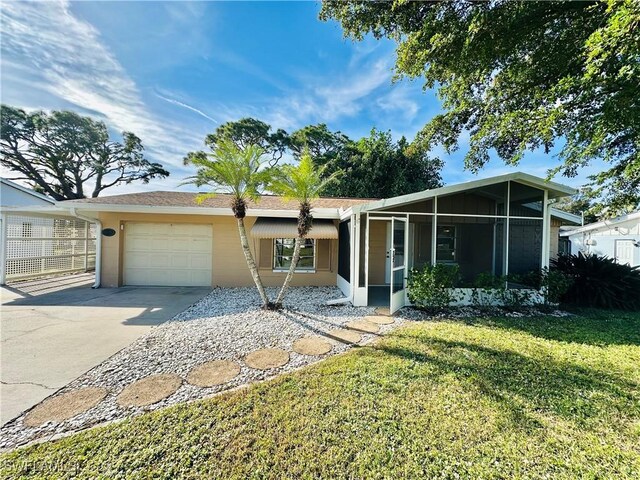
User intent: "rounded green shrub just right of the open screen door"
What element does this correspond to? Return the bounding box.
[407,263,460,309]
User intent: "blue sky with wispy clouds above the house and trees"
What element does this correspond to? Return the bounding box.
[0,1,590,194]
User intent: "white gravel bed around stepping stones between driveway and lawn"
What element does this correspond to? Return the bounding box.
[0,287,404,449]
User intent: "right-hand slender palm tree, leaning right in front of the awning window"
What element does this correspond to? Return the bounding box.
[269,149,341,308]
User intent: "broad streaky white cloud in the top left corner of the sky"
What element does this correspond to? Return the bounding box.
[2,1,201,171]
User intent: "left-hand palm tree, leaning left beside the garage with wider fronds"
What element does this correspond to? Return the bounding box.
[183,140,273,309]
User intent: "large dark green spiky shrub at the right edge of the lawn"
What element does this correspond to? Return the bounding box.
[552,253,640,310]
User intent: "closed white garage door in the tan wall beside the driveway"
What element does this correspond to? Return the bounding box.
[124,223,213,287]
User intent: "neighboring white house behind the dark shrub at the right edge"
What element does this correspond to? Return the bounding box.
[560,211,640,266]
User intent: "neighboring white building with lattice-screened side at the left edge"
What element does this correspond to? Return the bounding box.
[0,178,95,284]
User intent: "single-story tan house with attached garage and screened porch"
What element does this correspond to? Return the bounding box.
[8,173,575,310]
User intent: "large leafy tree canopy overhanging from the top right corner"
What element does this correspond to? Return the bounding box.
[320,0,640,212]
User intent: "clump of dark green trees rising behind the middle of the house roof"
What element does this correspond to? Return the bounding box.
[194,118,443,198]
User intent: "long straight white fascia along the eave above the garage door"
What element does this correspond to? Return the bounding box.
[57,202,340,220]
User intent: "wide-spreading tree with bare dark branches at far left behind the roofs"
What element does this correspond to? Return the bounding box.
[0,105,169,200]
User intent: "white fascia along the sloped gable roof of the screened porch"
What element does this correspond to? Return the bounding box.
[353,172,578,212]
